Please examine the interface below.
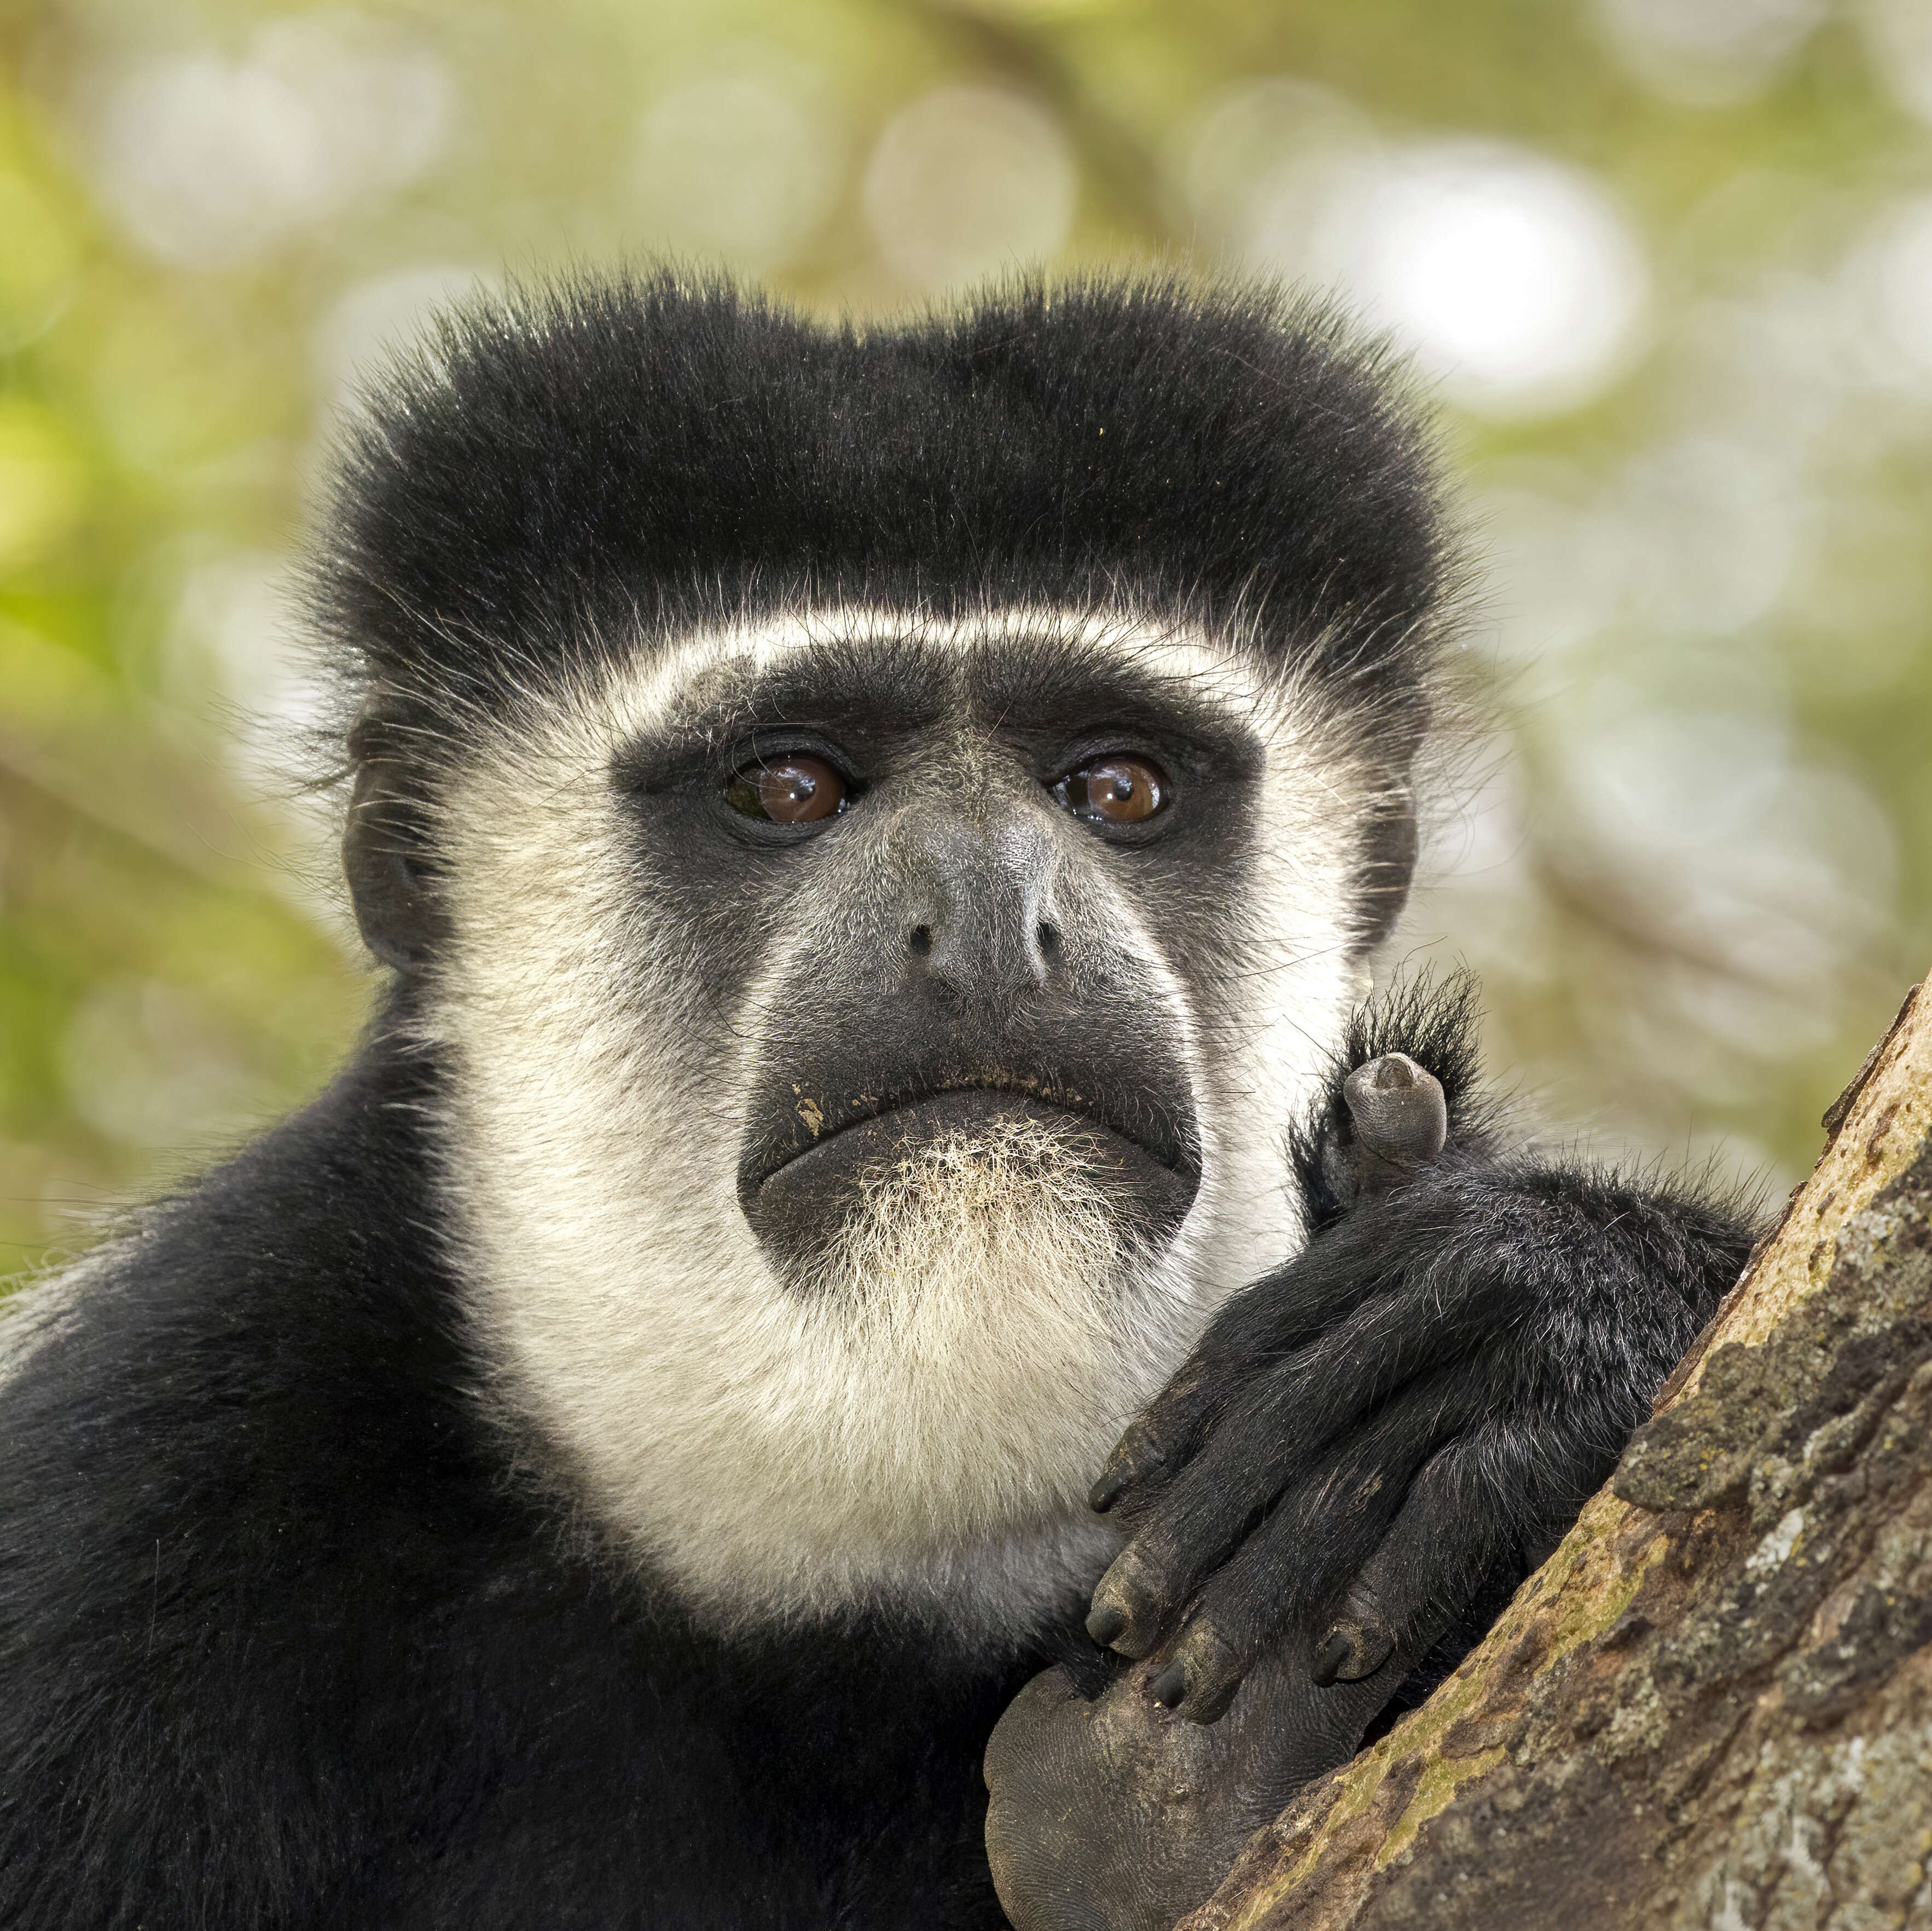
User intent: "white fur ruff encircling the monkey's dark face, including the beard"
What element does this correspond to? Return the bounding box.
[427,608,1391,1632]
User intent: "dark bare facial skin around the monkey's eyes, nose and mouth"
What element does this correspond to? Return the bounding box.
[595,647,1258,1282]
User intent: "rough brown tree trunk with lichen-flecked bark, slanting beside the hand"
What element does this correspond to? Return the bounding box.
[1182,983,1932,1931]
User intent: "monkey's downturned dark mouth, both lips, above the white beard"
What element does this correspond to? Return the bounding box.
[738,1075,1200,1259]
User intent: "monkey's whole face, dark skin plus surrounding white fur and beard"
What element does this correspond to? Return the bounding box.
[388,608,1376,1630]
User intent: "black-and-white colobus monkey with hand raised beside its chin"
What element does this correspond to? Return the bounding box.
[0,276,1749,1931]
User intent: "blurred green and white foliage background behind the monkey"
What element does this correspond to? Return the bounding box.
[0,0,1932,1272]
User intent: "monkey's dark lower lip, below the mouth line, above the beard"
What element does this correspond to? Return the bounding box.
[742,1089,1198,1243]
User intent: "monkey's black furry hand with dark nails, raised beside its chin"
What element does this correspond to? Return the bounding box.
[1088,1062,1750,1723]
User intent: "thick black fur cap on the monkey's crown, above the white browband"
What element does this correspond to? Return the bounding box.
[336,272,1460,968]
